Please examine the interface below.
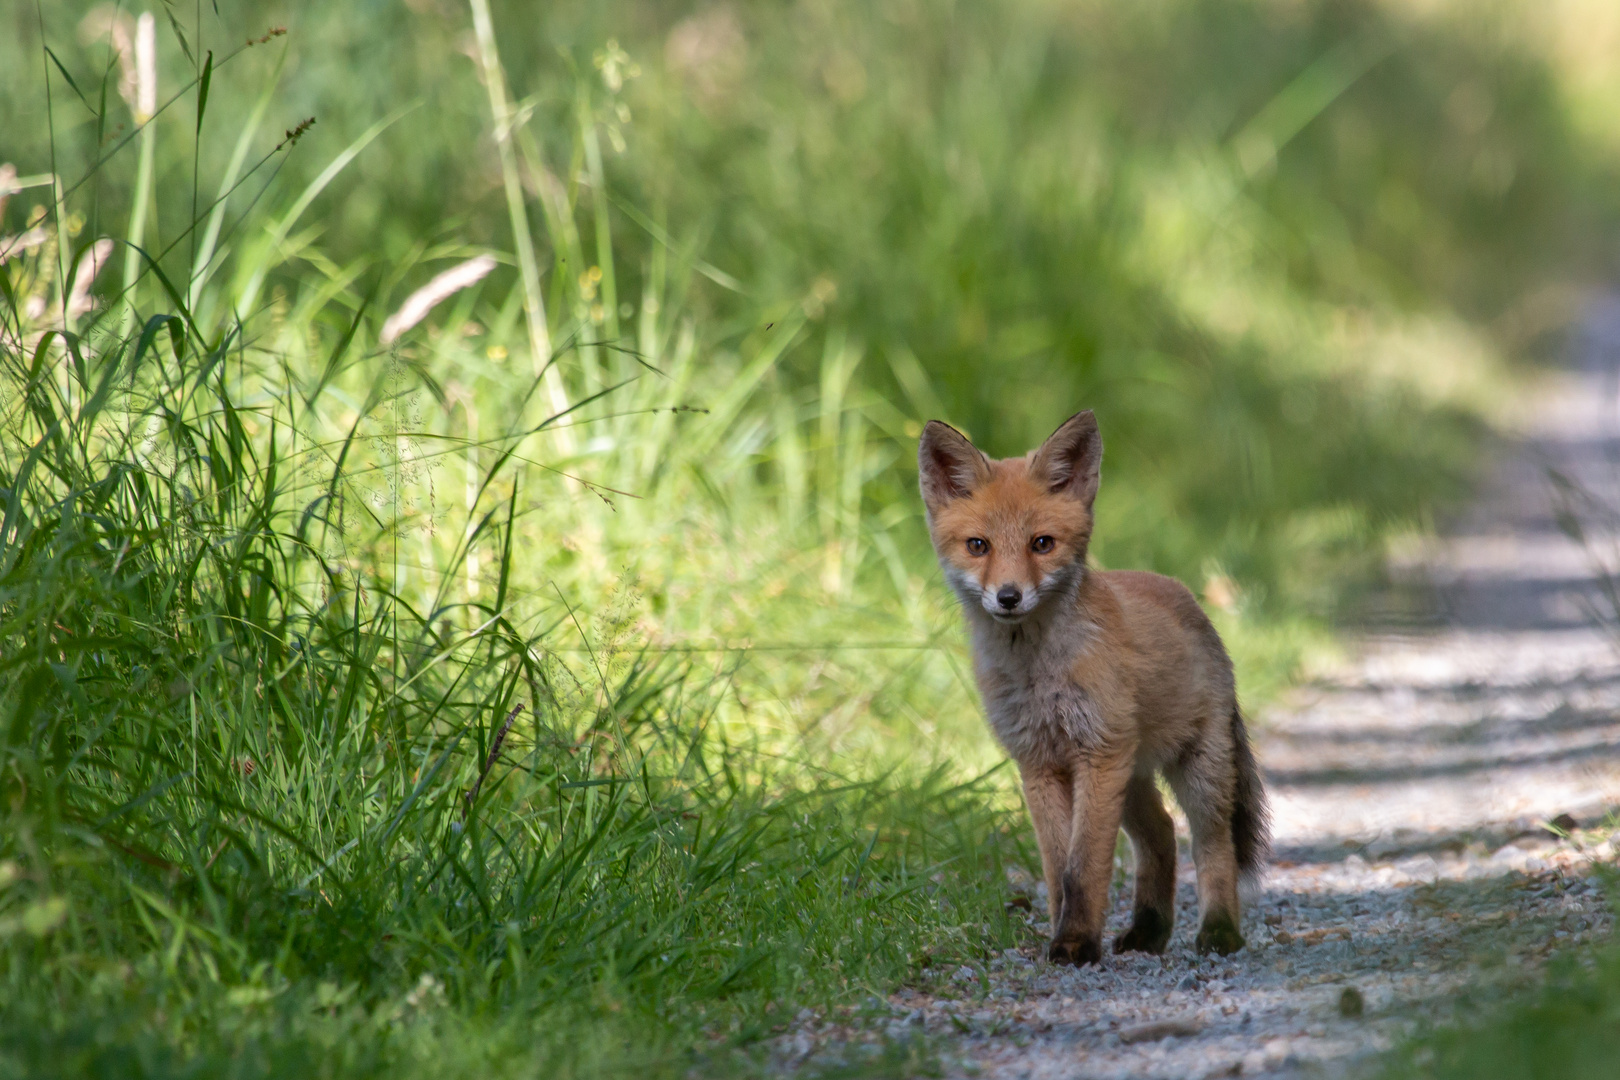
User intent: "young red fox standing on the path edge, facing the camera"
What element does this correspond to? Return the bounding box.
[917,410,1270,963]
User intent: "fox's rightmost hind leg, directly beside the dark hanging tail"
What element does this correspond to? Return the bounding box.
[1165,735,1244,955]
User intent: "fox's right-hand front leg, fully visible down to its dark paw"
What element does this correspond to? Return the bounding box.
[1048,758,1131,963]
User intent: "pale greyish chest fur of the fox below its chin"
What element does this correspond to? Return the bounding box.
[969,612,1106,767]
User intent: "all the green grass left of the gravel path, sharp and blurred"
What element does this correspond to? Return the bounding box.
[0,0,1615,1077]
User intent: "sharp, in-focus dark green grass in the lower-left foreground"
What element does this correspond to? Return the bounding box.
[0,281,1027,1075]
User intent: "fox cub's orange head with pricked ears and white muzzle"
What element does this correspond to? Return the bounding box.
[917,410,1103,623]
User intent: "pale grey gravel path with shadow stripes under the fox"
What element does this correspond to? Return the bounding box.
[781,303,1620,1080]
